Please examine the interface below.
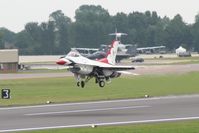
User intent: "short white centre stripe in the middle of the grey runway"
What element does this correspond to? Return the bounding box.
[24,106,151,116]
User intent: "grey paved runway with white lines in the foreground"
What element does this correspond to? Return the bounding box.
[0,95,199,132]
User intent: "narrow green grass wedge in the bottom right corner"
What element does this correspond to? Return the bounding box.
[23,120,199,133]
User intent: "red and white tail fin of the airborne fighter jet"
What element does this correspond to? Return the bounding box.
[99,40,119,65]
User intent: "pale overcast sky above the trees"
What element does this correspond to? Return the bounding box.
[0,0,199,32]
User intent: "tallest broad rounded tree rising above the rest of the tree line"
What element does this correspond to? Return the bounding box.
[73,5,113,47]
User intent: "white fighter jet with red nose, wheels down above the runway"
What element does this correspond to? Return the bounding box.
[57,40,135,88]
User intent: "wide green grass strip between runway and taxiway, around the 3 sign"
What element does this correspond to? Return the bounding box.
[0,72,199,106]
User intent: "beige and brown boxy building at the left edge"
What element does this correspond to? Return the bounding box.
[0,49,19,73]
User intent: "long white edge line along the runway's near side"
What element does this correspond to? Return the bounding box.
[0,116,199,133]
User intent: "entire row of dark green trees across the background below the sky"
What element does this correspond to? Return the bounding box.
[0,5,199,55]
